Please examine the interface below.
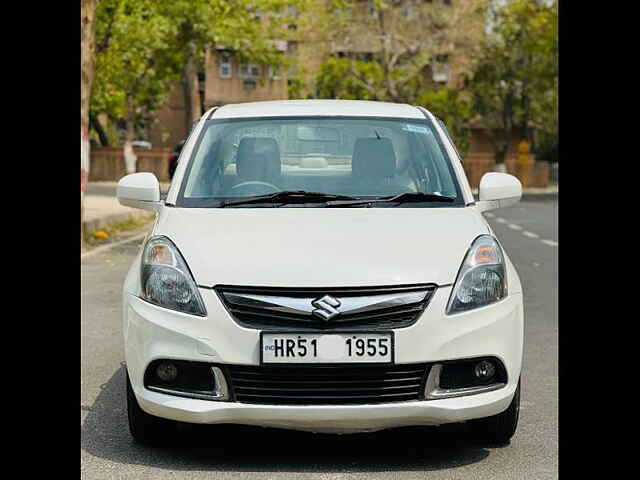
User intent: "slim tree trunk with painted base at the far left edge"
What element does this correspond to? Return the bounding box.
[80,0,97,248]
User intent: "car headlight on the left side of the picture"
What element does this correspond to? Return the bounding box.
[140,237,207,316]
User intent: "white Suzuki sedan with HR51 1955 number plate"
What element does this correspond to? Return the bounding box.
[118,100,524,443]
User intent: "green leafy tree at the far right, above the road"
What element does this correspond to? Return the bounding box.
[467,0,558,162]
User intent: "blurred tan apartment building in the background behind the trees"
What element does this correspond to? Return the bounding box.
[150,0,487,147]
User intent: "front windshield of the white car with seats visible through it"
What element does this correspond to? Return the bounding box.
[176,117,464,207]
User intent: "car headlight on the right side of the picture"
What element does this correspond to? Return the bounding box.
[447,235,507,315]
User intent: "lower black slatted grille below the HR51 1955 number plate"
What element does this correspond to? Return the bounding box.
[226,363,428,405]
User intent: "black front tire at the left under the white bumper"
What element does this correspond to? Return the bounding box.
[127,372,175,446]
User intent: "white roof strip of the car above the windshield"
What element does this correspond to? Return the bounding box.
[210,100,425,119]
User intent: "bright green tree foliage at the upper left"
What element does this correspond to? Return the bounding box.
[91,0,306,143]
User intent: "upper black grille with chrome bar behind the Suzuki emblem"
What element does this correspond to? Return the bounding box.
[215,284,436,330]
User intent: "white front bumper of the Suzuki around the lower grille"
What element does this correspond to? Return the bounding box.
[123,287,523,433]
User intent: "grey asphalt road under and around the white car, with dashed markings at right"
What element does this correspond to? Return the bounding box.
[80,197,558,480]
